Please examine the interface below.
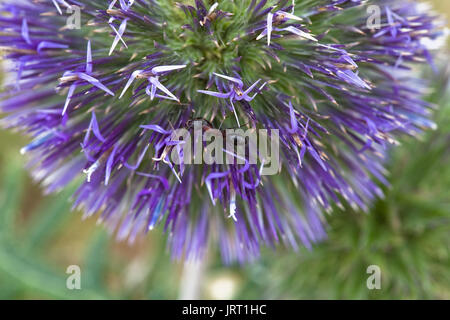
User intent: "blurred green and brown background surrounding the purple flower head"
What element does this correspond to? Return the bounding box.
[0,0,450,299]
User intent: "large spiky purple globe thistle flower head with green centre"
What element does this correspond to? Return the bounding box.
[0,0,441,262]
